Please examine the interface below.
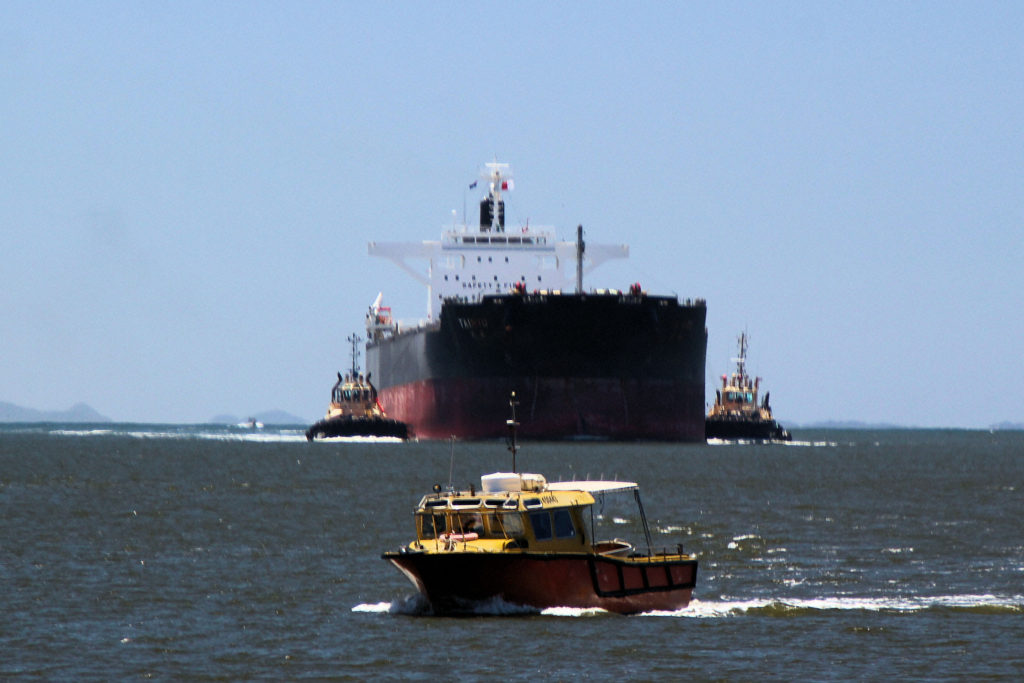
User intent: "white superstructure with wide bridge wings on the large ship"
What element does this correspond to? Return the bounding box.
[369,162,629,319]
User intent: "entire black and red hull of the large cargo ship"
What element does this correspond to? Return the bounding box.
[367,293,707,441]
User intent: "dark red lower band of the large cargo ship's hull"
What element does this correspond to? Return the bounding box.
[380,377,705,441]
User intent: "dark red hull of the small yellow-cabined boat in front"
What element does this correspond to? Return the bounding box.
[384,552,697,614]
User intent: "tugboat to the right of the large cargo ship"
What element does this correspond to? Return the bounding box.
[705,332,791,441]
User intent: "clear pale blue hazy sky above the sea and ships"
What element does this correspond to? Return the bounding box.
[0,1,1024,427]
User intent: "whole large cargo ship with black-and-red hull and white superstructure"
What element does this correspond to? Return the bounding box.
[367,163,708,441]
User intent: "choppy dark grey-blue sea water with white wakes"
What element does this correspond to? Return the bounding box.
[0,425,1024,680]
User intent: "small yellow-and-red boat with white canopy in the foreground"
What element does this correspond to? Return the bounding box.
[382,393,697,614]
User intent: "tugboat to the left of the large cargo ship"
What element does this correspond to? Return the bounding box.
[306,335,410,441]
